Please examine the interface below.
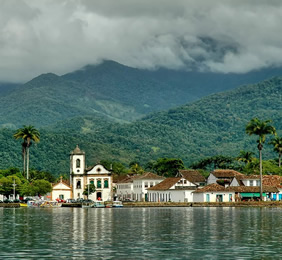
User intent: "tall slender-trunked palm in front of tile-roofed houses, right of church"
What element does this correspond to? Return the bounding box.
[246,118,276,200]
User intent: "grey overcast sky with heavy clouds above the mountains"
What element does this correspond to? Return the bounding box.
[0,0,282,82]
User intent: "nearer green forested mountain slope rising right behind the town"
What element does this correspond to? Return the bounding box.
[0,77,282,174]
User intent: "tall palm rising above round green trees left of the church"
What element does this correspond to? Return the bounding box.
[14,125,40,179]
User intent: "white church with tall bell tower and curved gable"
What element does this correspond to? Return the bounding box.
[70,145,113,201]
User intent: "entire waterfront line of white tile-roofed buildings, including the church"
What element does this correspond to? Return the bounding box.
[50,146,282,202]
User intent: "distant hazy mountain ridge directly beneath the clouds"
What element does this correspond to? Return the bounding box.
[0,61,282,128]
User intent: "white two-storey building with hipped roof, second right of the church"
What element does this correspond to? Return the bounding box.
[133,172,165,201]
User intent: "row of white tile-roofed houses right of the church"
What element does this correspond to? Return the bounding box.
[116,170,282,202]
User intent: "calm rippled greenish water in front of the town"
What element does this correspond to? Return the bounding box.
[0,208,282,260]
